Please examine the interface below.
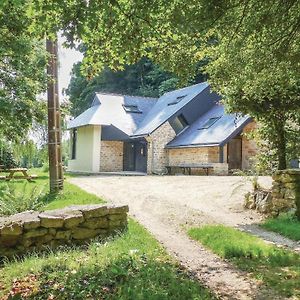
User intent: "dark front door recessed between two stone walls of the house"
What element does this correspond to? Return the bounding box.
[123,141,147,172]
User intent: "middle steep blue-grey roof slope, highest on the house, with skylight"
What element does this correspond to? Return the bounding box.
[133,82,209,136]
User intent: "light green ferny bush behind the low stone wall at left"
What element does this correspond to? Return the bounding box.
[0,183,45,216]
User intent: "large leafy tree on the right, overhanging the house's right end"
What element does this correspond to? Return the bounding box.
[205,1,300,169]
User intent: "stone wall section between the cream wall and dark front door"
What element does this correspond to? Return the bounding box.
[100,141,123,172]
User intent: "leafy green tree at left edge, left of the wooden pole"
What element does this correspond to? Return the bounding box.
[0,2,46,140]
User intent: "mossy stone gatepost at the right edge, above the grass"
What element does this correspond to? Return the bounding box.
[272,169,300,220]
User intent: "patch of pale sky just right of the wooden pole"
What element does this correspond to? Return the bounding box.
[58,36,83,101]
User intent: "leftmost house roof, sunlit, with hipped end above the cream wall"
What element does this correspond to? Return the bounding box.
[68,93,157,136]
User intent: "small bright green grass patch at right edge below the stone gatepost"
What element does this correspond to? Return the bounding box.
[261,214,300,241]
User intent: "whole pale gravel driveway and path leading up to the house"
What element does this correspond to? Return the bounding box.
[70,176,295,299]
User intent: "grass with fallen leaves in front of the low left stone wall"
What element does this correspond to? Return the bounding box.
[0,220,214,300]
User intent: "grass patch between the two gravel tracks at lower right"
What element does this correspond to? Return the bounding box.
[188,225,300,298]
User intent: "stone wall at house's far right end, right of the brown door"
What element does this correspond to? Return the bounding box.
[242,122,258,170]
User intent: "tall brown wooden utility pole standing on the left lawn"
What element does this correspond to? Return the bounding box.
[46,39,64,193]
